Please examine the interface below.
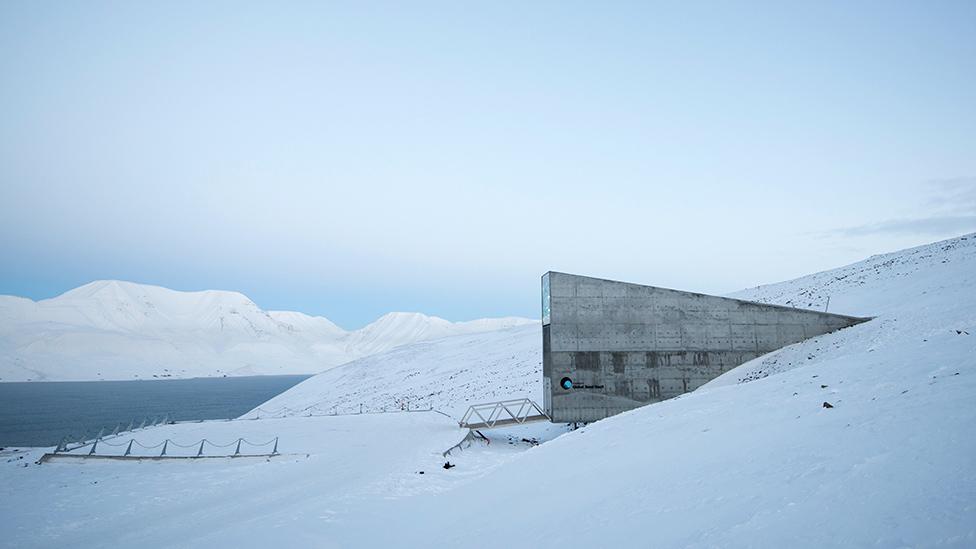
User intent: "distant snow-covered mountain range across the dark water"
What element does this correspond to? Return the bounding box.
[0,281,533,381]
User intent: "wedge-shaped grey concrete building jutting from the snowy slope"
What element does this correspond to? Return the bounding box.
[542,272,870,422]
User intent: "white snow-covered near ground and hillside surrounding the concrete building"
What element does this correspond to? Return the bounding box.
[0,235,976,548]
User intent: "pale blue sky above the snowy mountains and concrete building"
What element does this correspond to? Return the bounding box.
[0,2,976,328]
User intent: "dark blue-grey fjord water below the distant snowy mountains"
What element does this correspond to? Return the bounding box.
[0,376,309,447]
